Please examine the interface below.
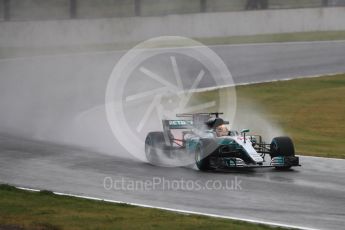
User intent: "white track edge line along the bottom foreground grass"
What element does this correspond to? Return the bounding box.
[16,187,318,230]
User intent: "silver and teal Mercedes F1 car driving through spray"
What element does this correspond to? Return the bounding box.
[145,112,300,171]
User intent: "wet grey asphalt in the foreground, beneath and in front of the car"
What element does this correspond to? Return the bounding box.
[0,136,345,229]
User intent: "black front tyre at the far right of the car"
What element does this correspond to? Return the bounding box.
[270,137,295,169]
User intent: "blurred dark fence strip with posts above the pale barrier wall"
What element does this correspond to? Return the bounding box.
[0,0,345,21]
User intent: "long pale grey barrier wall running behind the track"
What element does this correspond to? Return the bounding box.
[0,7,345,48]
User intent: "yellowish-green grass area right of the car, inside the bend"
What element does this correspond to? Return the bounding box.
[203,74,345,159]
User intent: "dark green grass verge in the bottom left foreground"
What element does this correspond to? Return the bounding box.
[0,185,288,230]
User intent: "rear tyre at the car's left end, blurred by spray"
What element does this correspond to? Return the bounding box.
[145,132,165,165]
